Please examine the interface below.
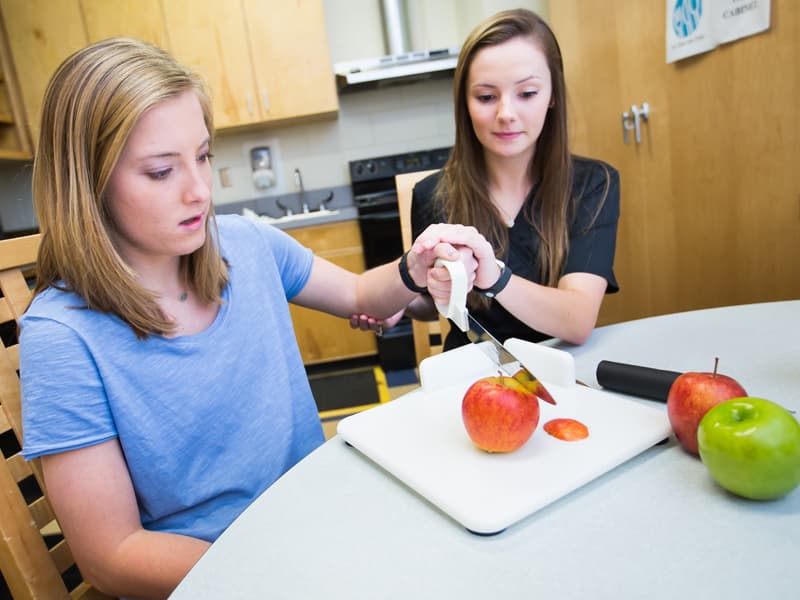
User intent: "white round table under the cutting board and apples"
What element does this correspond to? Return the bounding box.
[171,301,800,600]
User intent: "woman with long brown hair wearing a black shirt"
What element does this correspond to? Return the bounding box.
[351,9,619,349]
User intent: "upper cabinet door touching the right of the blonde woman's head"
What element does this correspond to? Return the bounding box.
[163,0,263,127]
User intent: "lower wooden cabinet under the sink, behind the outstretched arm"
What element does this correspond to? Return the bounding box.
[286,221,378,365]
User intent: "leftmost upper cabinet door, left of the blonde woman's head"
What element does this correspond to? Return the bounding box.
[0,0,87,144]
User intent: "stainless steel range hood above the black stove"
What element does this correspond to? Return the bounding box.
[333,0,459,93]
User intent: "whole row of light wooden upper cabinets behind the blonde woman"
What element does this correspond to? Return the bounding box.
[0,0,338,141]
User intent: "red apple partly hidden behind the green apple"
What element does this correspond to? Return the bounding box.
[667,359,747,455]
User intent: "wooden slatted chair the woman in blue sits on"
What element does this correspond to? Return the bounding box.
[0,234,109,600]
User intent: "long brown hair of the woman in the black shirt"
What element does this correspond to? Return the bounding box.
[436,9,571,296]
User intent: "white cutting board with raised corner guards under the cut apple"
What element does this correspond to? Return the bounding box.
[337,341,672,534]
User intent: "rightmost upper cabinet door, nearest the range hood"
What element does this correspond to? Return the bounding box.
[244,0,339,121]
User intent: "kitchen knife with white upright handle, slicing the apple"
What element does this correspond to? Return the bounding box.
[436,259,556,404]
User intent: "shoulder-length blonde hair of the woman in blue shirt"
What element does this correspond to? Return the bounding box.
[33,38,228,338]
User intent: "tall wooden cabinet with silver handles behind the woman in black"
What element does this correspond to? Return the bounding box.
[550,0,800,323]
